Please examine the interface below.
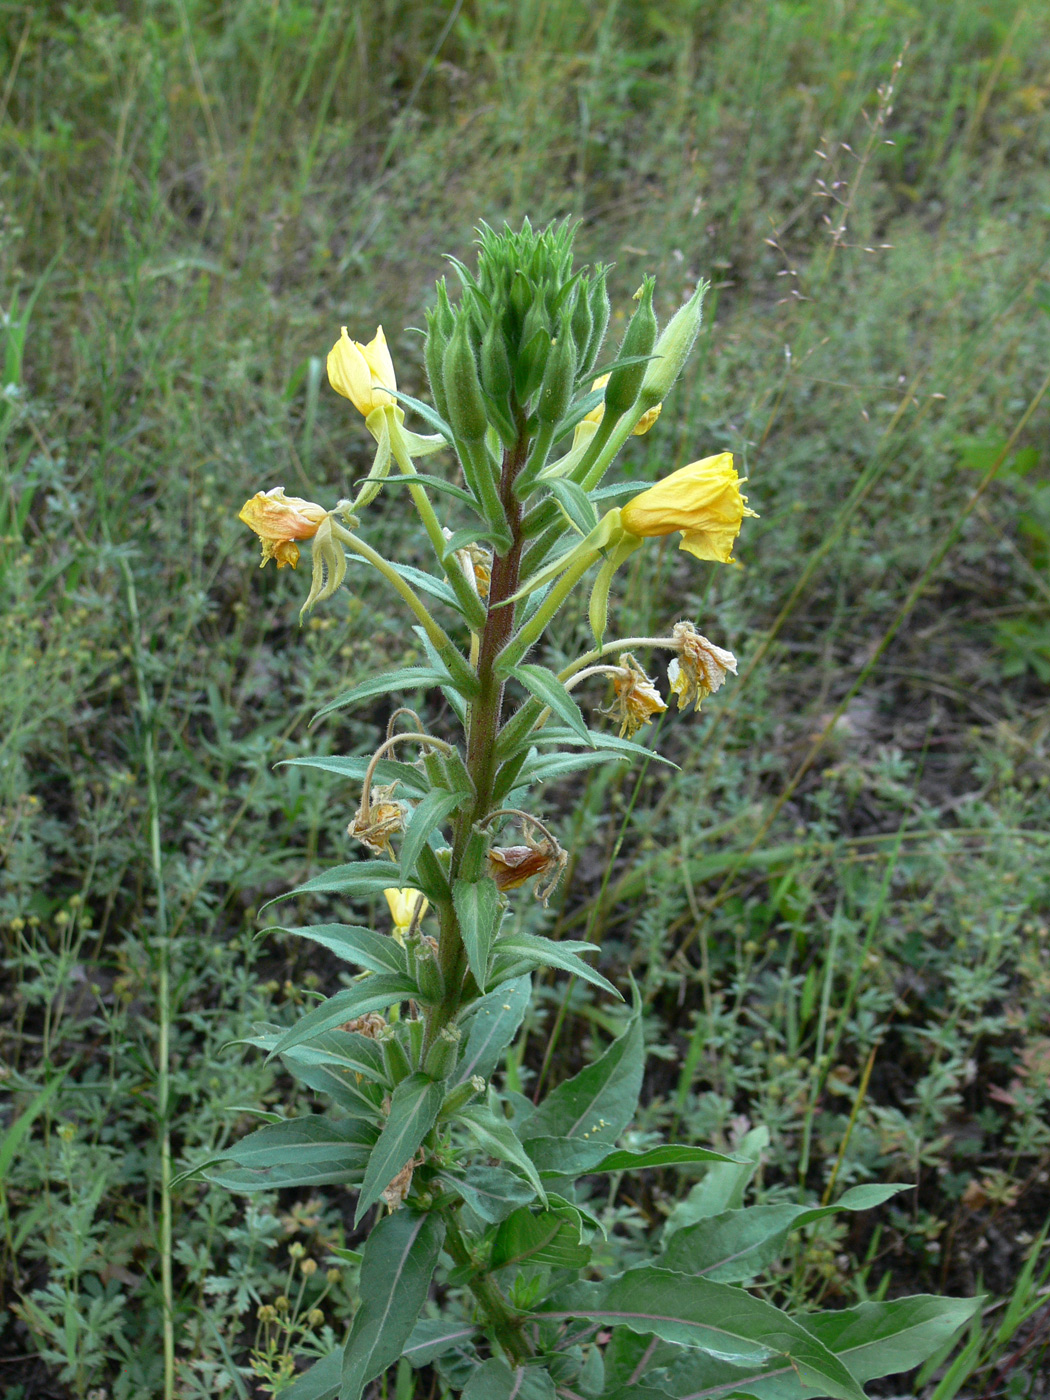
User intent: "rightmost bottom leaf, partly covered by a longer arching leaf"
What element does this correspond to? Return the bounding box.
[649,1294,981,1400]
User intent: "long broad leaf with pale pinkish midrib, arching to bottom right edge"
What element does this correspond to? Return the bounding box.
[535,1266,865,1400]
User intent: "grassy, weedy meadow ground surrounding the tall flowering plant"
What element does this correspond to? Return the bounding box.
[0,0,1050,1400]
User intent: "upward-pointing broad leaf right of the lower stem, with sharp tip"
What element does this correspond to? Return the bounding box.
[522,988,645,1149]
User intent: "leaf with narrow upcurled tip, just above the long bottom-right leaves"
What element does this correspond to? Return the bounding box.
[655,1184,909,1284]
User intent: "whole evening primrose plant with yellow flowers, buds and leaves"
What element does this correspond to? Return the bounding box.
[224,223,973,1400]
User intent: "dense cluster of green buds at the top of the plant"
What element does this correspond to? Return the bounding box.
[426,220,613,445]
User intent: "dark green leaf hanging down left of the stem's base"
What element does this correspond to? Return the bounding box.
[339,1205,445,1400]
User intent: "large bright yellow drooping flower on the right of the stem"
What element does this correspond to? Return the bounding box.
[620,452,755,564]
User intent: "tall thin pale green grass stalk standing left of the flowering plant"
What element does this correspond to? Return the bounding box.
[120,559,175,1400]
